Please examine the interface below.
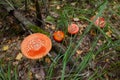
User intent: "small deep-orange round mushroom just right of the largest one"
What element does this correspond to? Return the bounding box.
[53,31,65,42]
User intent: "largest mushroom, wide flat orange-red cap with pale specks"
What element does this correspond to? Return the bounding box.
[21,33,52,59]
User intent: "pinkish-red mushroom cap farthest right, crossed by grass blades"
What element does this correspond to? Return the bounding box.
[91,16,105,28]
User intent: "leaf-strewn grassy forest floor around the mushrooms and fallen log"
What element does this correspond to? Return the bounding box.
[0,0,120,80]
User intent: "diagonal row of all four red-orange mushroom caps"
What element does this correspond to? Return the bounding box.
[21,16,105,59]
